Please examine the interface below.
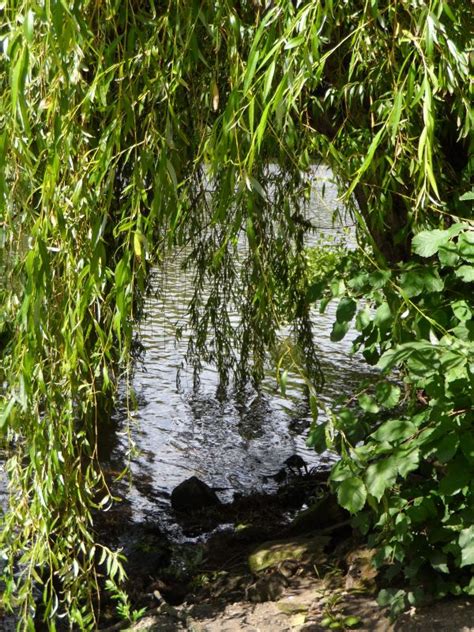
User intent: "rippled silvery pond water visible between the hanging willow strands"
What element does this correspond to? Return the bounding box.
[105,169,376,527]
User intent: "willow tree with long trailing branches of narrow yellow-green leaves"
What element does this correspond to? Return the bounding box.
[0,0,470,629]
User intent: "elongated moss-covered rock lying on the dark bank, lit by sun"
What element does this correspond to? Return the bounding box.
[248,536,331,573]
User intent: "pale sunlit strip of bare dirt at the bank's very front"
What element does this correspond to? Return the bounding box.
[116,582,474,632]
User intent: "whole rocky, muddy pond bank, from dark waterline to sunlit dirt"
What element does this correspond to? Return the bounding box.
[97,460,474,632]
